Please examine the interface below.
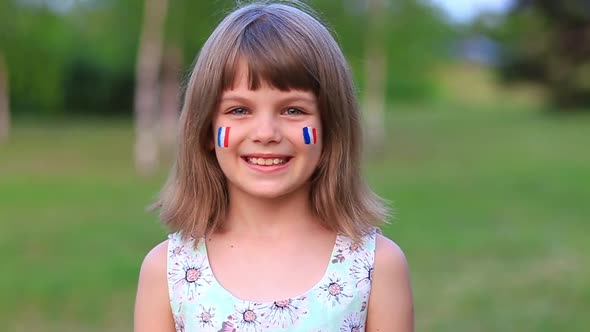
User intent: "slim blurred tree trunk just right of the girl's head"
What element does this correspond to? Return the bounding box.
[363,0,387,156]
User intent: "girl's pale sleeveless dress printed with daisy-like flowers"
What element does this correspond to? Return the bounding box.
[167,228,377,332]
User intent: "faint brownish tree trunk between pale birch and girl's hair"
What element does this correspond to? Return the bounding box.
[160,45,182,158]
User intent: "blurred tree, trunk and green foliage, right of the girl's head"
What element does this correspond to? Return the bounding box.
[314,0,455,156]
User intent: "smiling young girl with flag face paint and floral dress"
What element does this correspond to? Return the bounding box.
[135,2,413,332]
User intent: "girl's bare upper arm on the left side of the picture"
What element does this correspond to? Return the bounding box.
[133,241,174,332]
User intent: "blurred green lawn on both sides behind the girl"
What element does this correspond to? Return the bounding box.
[0,107,590,331]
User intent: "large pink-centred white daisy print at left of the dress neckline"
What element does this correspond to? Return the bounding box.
[168,253,213,301]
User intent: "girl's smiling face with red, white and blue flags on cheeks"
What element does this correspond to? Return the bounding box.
[213,64,322,198]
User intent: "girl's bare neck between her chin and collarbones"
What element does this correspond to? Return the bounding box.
[224,184,319,237]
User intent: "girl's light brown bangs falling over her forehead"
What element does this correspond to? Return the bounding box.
[222,14,320,96]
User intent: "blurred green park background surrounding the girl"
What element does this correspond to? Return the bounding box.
[0,0,590,331]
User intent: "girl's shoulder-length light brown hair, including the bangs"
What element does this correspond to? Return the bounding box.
[154,1,388,241]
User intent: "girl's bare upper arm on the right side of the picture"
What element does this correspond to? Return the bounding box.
[366,234,414,332]
